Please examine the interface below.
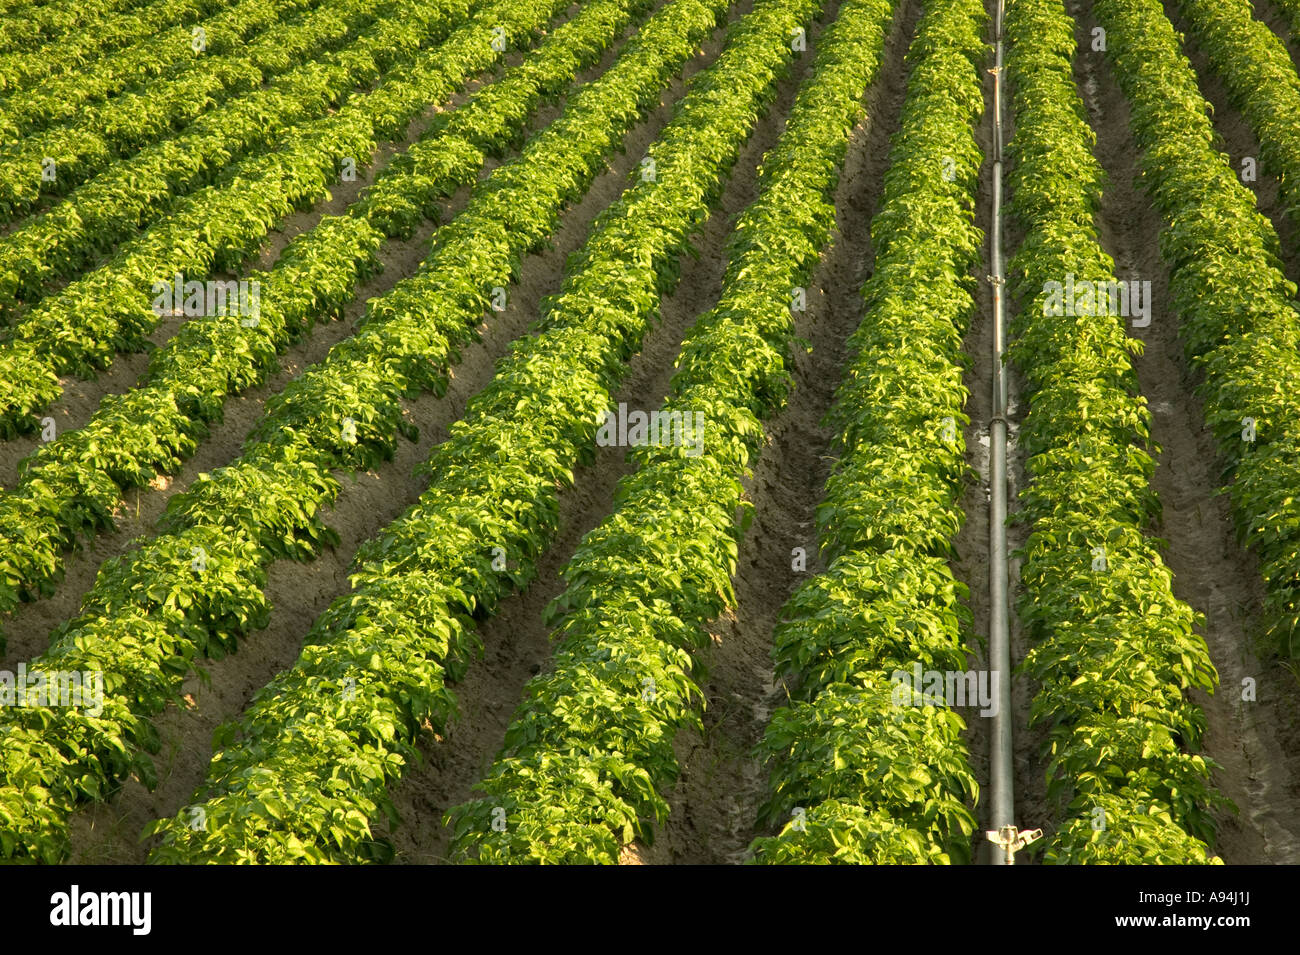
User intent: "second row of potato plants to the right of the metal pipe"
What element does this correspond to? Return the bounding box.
[1096,0,1300,655]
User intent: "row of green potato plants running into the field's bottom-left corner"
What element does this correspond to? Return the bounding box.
[0,0,727,860]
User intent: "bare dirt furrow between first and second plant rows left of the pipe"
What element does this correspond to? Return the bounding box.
[628,0,920,864]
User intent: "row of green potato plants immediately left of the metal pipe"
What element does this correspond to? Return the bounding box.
[751,0,988,864]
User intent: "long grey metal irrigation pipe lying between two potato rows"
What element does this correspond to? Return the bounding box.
[988,0,1015,865]
